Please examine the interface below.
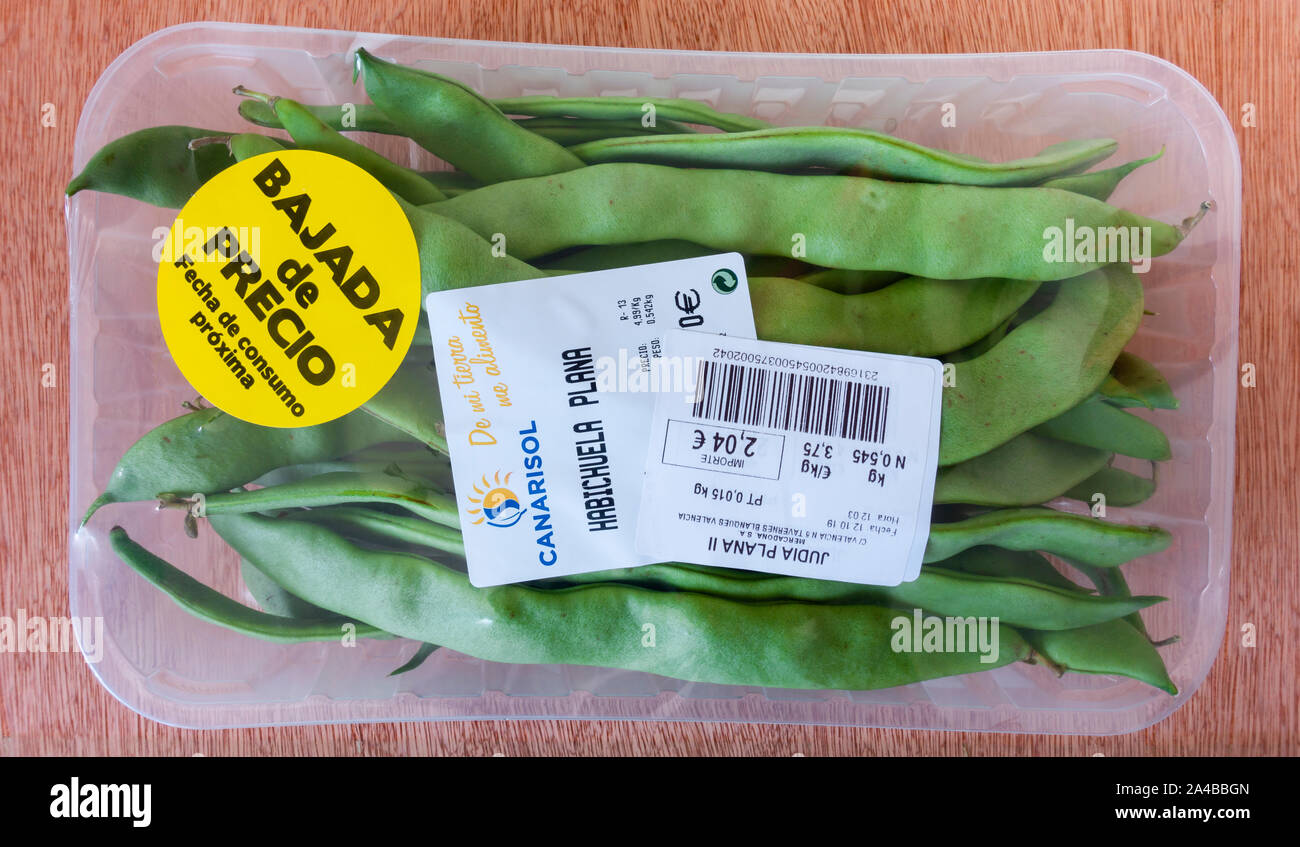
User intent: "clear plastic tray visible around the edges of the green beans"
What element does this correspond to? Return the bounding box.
[68,23,1242,734]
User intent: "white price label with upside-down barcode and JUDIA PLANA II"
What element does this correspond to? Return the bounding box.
[637,333,943,586]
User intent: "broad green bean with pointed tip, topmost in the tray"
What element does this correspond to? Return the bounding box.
[354,48,582,182]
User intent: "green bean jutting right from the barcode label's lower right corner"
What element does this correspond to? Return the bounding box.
[924,508,1171,568]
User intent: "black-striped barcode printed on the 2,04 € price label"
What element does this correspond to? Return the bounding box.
[692,361,889,444]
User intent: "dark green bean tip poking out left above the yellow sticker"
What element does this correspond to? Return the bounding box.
[68,126,245,209]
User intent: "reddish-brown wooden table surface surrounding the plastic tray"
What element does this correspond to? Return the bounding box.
[0,0,1300,756]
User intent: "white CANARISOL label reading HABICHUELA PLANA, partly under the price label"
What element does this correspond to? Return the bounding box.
[425,253,754,586]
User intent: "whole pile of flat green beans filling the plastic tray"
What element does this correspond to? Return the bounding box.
[68,49,1208,694]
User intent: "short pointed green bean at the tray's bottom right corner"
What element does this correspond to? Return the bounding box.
[1022,620,1178,694]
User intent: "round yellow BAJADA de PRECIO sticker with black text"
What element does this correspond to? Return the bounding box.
[159,149,421,426]
